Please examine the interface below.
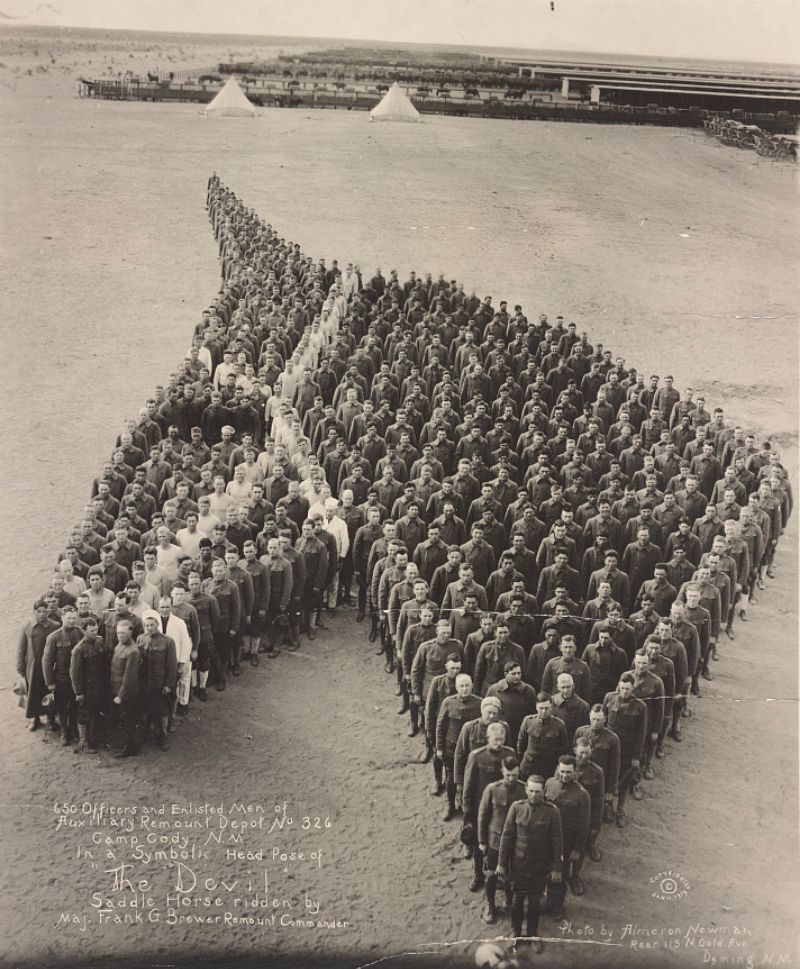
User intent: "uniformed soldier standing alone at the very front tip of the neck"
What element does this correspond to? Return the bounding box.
[496,774,564,953]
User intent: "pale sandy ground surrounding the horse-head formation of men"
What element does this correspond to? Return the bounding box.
[0,33,800,967]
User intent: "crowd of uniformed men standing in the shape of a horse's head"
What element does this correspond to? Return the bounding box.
[18,175,792,936]
